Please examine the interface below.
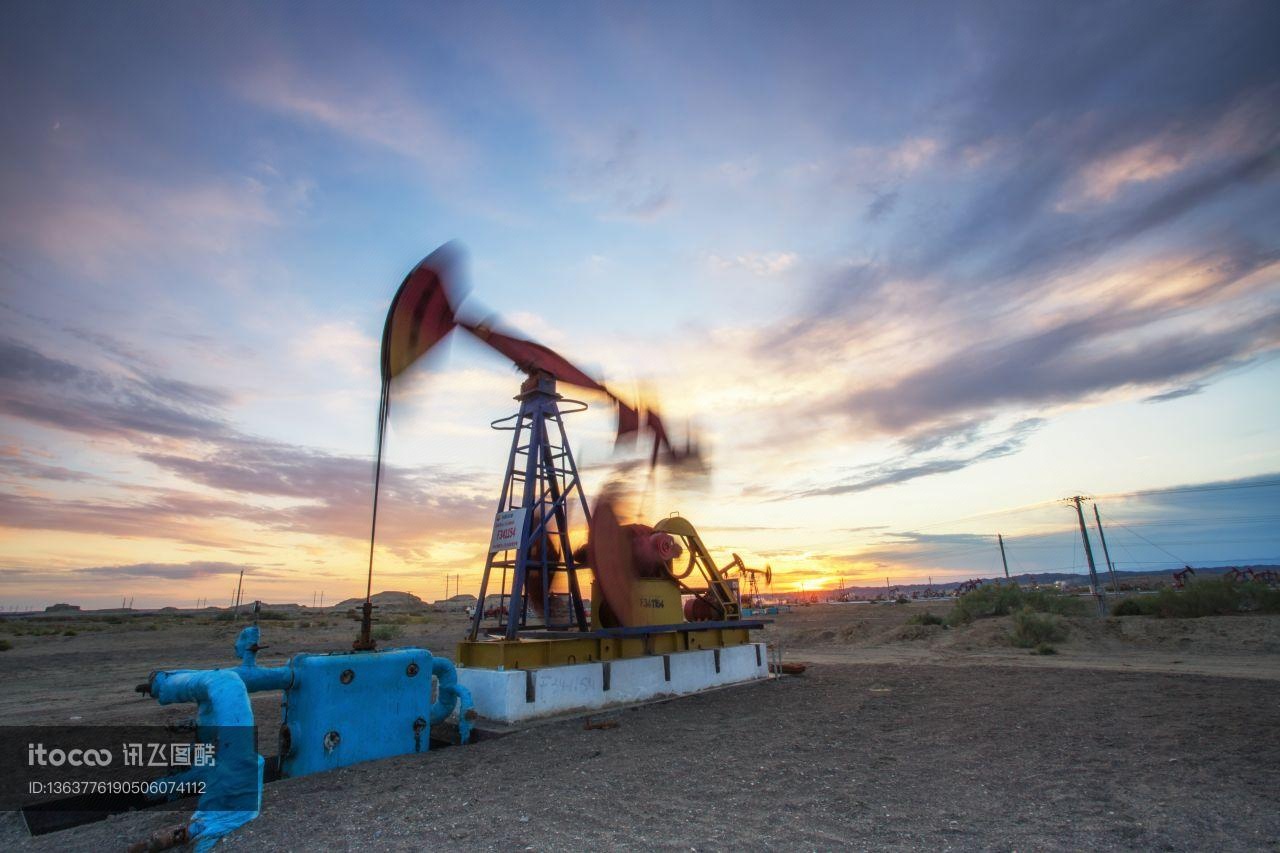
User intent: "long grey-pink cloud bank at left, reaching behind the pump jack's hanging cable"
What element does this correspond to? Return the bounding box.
[0,338,493,552]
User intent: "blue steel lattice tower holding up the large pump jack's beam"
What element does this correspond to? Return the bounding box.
[468,373,591,640]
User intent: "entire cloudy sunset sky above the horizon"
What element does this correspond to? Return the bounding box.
[0,1,1280,608]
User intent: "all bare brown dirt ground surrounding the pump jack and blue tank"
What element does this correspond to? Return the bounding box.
[0,603,1280,853]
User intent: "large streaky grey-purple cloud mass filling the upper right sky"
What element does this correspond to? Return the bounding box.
[755,6,1280,458]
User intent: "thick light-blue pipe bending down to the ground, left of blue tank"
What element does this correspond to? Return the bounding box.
[151,670,262,853]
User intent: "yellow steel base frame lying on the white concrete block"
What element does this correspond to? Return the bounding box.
[458,622,751,670]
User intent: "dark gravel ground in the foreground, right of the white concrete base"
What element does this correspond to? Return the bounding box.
[0,601,1280,853]
